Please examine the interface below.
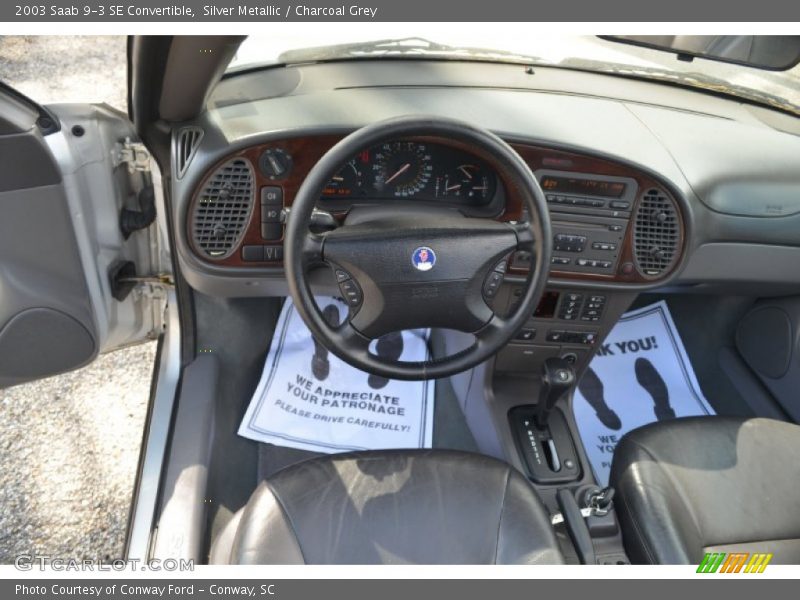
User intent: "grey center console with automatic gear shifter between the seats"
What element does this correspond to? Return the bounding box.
[478,280,637,564]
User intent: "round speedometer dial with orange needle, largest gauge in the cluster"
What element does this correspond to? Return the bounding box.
[372,142,433,198]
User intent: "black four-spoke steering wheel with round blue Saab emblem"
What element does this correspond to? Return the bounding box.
[284,117,552,380]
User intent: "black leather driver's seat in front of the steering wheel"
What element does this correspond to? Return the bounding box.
[210,450,563,564]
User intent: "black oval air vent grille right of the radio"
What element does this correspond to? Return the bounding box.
[633,189,681,278]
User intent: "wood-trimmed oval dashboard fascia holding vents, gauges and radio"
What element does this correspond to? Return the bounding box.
[186,135,686,290]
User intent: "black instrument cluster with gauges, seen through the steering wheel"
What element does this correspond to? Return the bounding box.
[321,141,497,207]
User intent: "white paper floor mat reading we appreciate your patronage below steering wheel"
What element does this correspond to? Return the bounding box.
[239,298,434,453]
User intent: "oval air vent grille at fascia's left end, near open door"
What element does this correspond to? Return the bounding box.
[191,158,255,258]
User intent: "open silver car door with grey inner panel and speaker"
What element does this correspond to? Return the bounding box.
[0,96,166,387]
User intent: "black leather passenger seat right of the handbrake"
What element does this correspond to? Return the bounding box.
[611,417,800,564]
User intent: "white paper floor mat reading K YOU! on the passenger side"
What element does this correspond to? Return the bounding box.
[573,301,714,485]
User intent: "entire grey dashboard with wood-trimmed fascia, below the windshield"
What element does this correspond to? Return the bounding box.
[172,60,800,342]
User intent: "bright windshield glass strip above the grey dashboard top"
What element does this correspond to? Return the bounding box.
[228,28,800,114]
